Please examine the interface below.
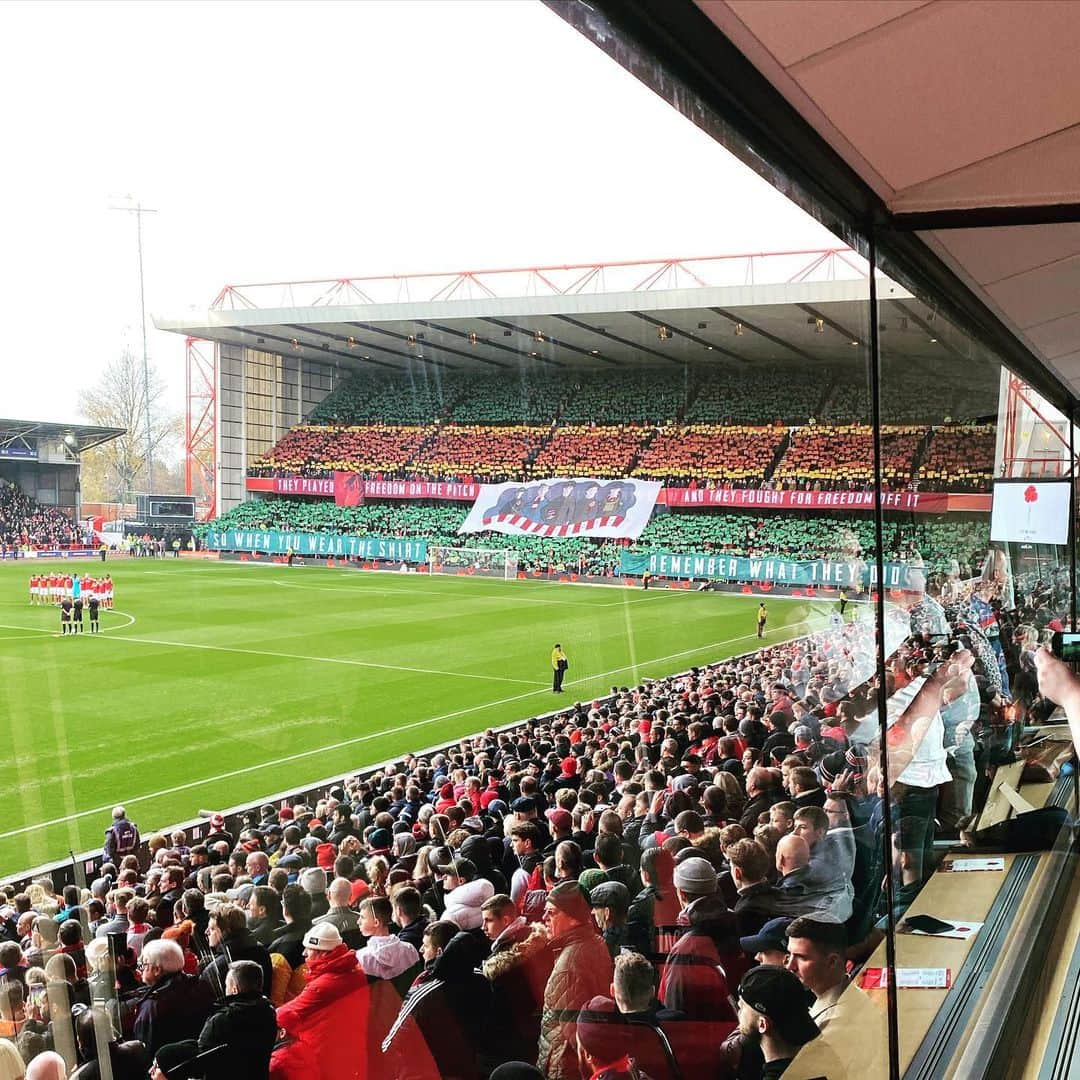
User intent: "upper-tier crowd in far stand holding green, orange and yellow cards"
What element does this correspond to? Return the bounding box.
[248,369,994,490]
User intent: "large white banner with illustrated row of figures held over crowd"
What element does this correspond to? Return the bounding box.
[458,476,662,539]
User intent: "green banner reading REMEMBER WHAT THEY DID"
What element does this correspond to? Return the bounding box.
[619,551,926,591]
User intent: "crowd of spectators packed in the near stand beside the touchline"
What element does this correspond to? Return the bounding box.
[0,572,1054,1080]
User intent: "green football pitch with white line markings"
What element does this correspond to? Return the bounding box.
[0,558,823,880]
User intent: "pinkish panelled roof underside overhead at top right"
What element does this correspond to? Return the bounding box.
[696,0,1080,392]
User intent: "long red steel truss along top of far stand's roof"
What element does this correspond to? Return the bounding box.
[211,247,867,311]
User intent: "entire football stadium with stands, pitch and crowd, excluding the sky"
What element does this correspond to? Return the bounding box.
[0,6,1080,1080]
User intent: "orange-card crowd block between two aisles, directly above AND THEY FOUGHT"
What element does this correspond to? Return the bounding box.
[633,423,787,487]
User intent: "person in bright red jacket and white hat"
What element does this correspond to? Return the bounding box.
[274,922,368,1080]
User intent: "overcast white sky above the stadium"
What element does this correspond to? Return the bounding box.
[0,0,835,421]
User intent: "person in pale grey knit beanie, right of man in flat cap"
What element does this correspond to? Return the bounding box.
[659,855,747,1024]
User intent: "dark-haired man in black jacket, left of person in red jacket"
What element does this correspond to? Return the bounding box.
[199,960,278,1080]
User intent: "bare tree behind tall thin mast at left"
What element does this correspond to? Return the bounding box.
[79,349,181,502]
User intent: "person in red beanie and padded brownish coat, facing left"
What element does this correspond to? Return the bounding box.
[537,881,612,1080]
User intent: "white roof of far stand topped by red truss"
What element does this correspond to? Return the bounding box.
[154,249,989,373]
